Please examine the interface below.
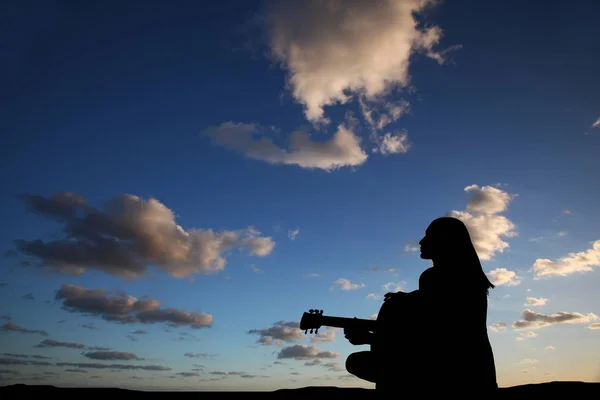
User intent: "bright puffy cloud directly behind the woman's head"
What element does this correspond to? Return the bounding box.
[448,185,517,260]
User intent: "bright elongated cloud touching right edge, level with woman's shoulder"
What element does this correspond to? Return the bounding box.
[532,240,600,279]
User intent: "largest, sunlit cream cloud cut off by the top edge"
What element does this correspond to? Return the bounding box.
[266,0,443,125]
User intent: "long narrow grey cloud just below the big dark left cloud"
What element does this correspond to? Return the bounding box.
[56,284,213,328]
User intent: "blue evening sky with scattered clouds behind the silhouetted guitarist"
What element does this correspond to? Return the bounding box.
[0,0,600,391]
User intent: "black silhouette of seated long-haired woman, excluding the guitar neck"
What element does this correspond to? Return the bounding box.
[344,217,498,396]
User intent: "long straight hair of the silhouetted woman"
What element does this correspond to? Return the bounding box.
[427,217,494,294]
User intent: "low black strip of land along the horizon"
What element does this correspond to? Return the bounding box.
[0,381,600,400]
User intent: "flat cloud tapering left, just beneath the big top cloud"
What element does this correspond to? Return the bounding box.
[205,122,368,171]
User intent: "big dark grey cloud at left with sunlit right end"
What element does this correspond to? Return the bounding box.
[15,192,275,279]
